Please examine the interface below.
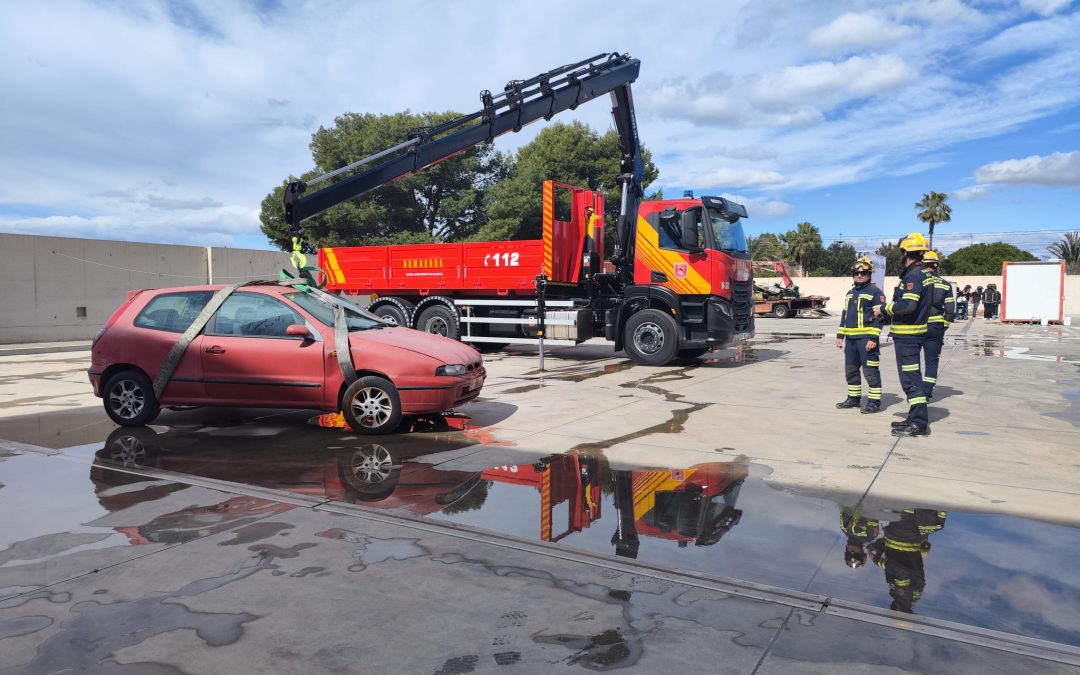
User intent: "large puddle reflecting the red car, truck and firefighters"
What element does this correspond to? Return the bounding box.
[59,421,1080,651]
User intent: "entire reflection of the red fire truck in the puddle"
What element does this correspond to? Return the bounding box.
[483,453,747,557]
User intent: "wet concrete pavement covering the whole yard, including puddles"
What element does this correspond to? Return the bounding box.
[0,321,1080,673]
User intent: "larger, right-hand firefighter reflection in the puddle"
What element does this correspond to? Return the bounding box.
[869,509,946,613]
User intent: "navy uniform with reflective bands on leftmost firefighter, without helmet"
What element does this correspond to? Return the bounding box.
[836,282,885,401]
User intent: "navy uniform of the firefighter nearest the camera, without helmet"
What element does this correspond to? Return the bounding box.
[885,262,931,427]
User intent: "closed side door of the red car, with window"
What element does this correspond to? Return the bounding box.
[200,292,325,407]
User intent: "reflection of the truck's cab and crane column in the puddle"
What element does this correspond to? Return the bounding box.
[611,462,747,558]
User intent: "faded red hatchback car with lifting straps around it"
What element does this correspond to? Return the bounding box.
[87,283,486,434]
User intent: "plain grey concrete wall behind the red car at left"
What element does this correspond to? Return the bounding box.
[0,233,292,343]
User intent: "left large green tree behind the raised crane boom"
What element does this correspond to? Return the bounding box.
[259,111,509,249]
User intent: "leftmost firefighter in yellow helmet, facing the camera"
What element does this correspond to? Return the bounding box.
[836,258,885,414]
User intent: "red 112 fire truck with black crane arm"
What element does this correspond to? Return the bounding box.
[285,54,754,365]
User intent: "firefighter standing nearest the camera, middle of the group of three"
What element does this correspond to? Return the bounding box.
[874,232,931,436]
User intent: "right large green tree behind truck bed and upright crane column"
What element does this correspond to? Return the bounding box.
[472,122,662,247]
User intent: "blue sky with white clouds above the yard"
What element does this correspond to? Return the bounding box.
[0,0,1080,255]
